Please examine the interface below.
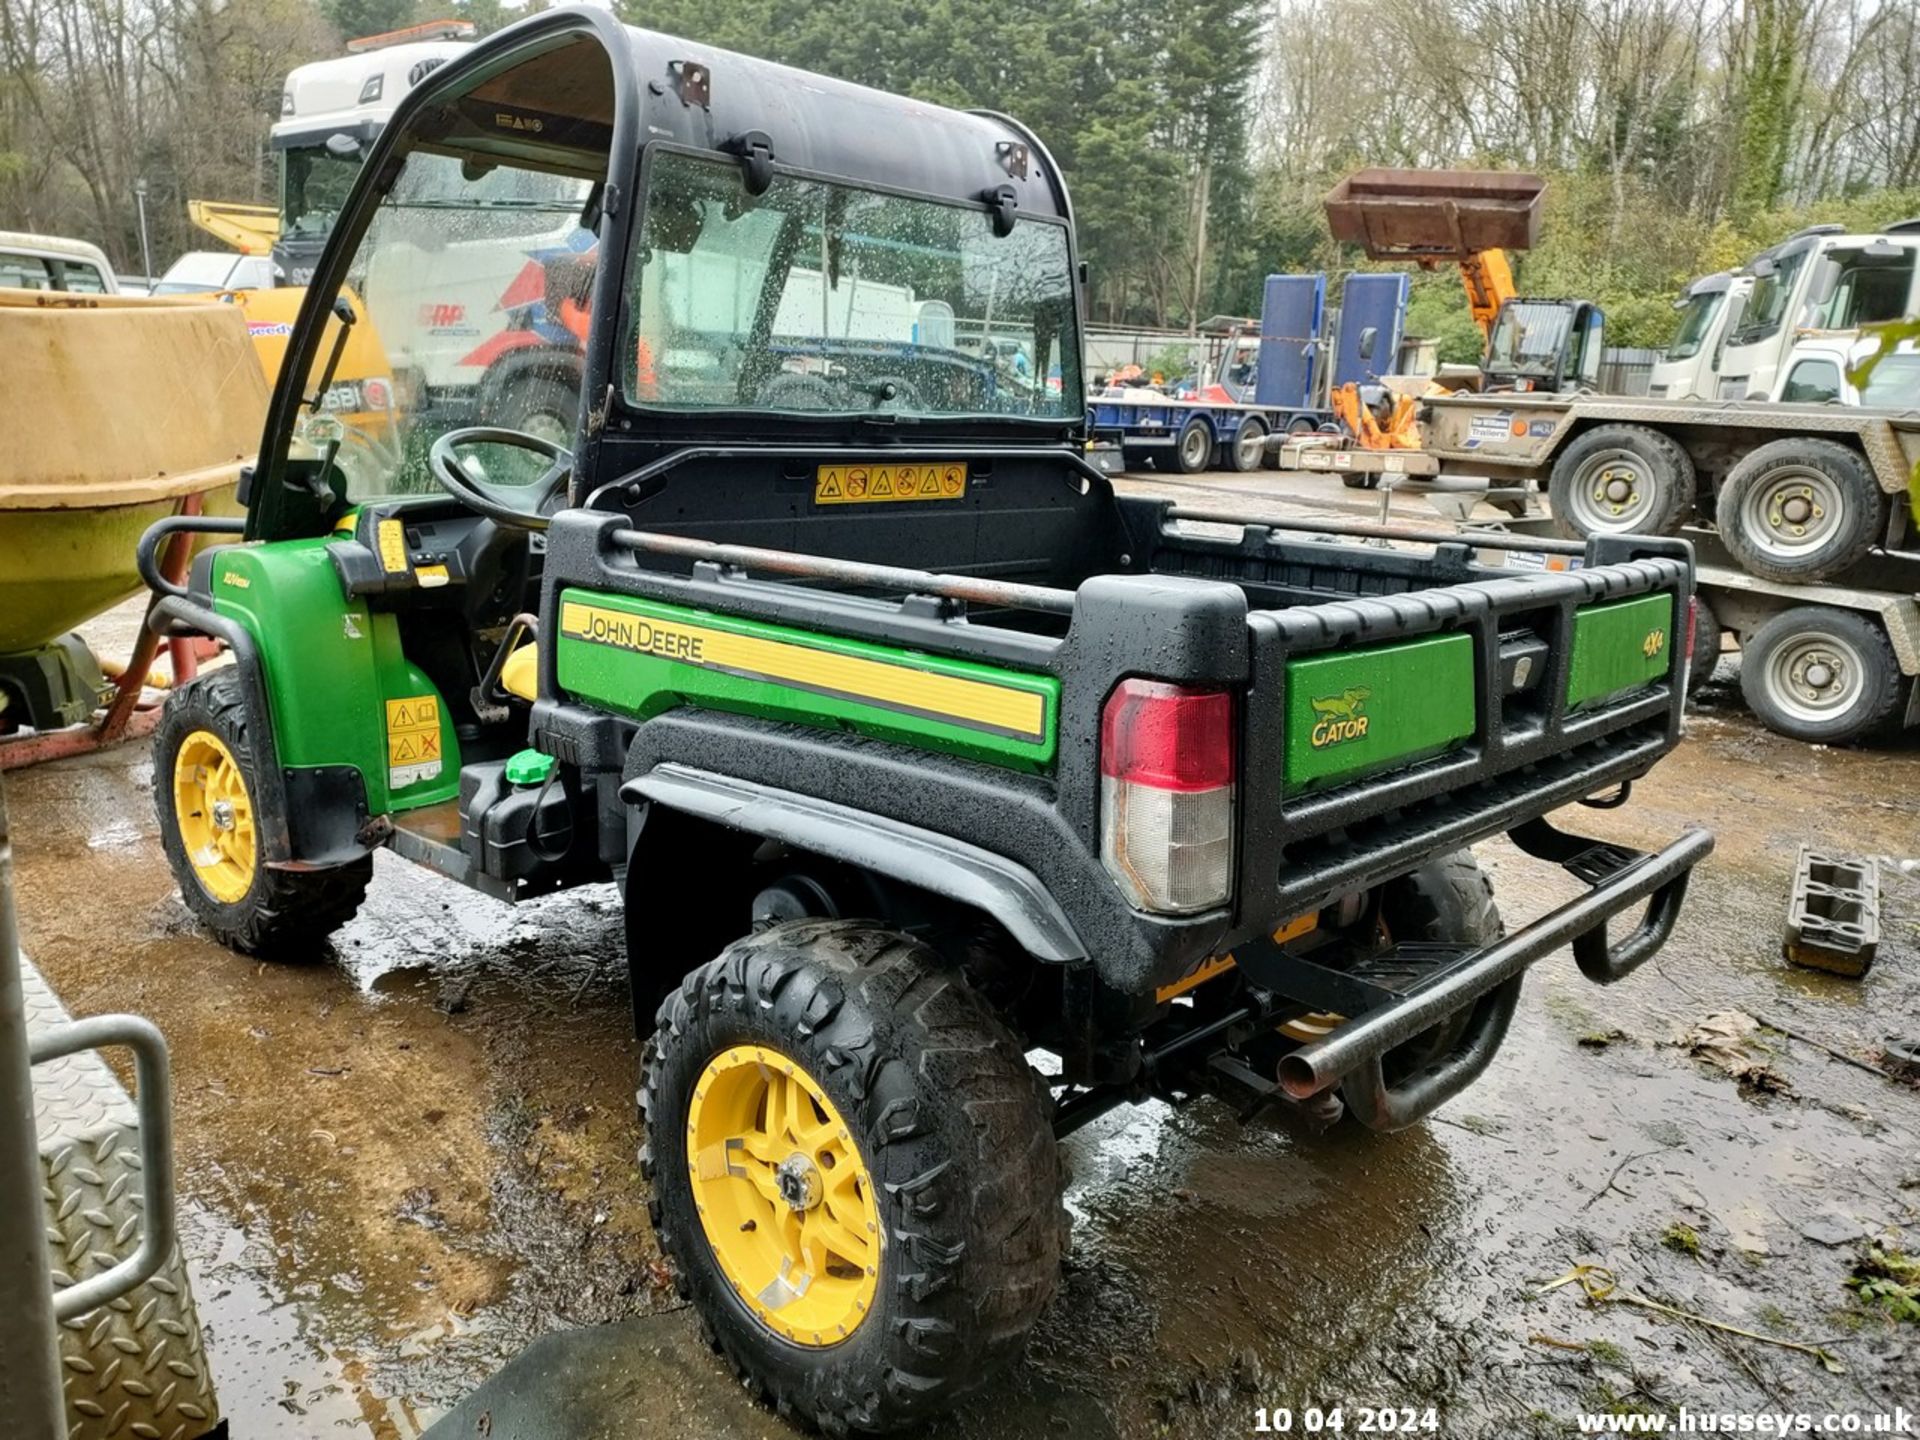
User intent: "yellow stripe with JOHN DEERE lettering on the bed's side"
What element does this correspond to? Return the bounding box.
[561,602,1046,739]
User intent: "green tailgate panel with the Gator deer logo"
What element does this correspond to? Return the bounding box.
[1286,636,1476,789]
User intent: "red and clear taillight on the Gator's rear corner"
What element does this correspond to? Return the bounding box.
[1100,680,1235,914]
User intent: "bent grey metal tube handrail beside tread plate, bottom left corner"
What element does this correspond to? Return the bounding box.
[27,1016,179,1321]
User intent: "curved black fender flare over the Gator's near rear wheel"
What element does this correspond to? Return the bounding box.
[620,760,1089,964]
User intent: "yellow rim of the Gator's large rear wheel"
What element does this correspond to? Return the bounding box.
[687,1044,883,1346]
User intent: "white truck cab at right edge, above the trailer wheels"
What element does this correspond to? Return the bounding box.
[1715,221,1920,399]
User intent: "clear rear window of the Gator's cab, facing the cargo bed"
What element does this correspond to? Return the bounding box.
[622,152,1081,422]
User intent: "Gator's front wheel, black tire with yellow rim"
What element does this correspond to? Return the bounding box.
[154,666,372,960]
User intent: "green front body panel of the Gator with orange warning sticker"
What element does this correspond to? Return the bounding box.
[211,538,461,814]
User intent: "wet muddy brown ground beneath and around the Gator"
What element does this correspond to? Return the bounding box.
[8,474,1920,1440]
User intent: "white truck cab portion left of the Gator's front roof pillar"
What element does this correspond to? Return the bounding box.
[267,21,474,284]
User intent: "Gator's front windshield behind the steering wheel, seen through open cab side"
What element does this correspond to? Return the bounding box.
[288,152,595,501]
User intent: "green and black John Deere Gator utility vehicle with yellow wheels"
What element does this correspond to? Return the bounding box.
[152,10,1711,1432]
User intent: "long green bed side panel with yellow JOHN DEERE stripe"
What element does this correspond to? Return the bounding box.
[556,589,1060,770]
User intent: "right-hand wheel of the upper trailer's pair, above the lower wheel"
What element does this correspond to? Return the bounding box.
[1716,436,1887,584]
